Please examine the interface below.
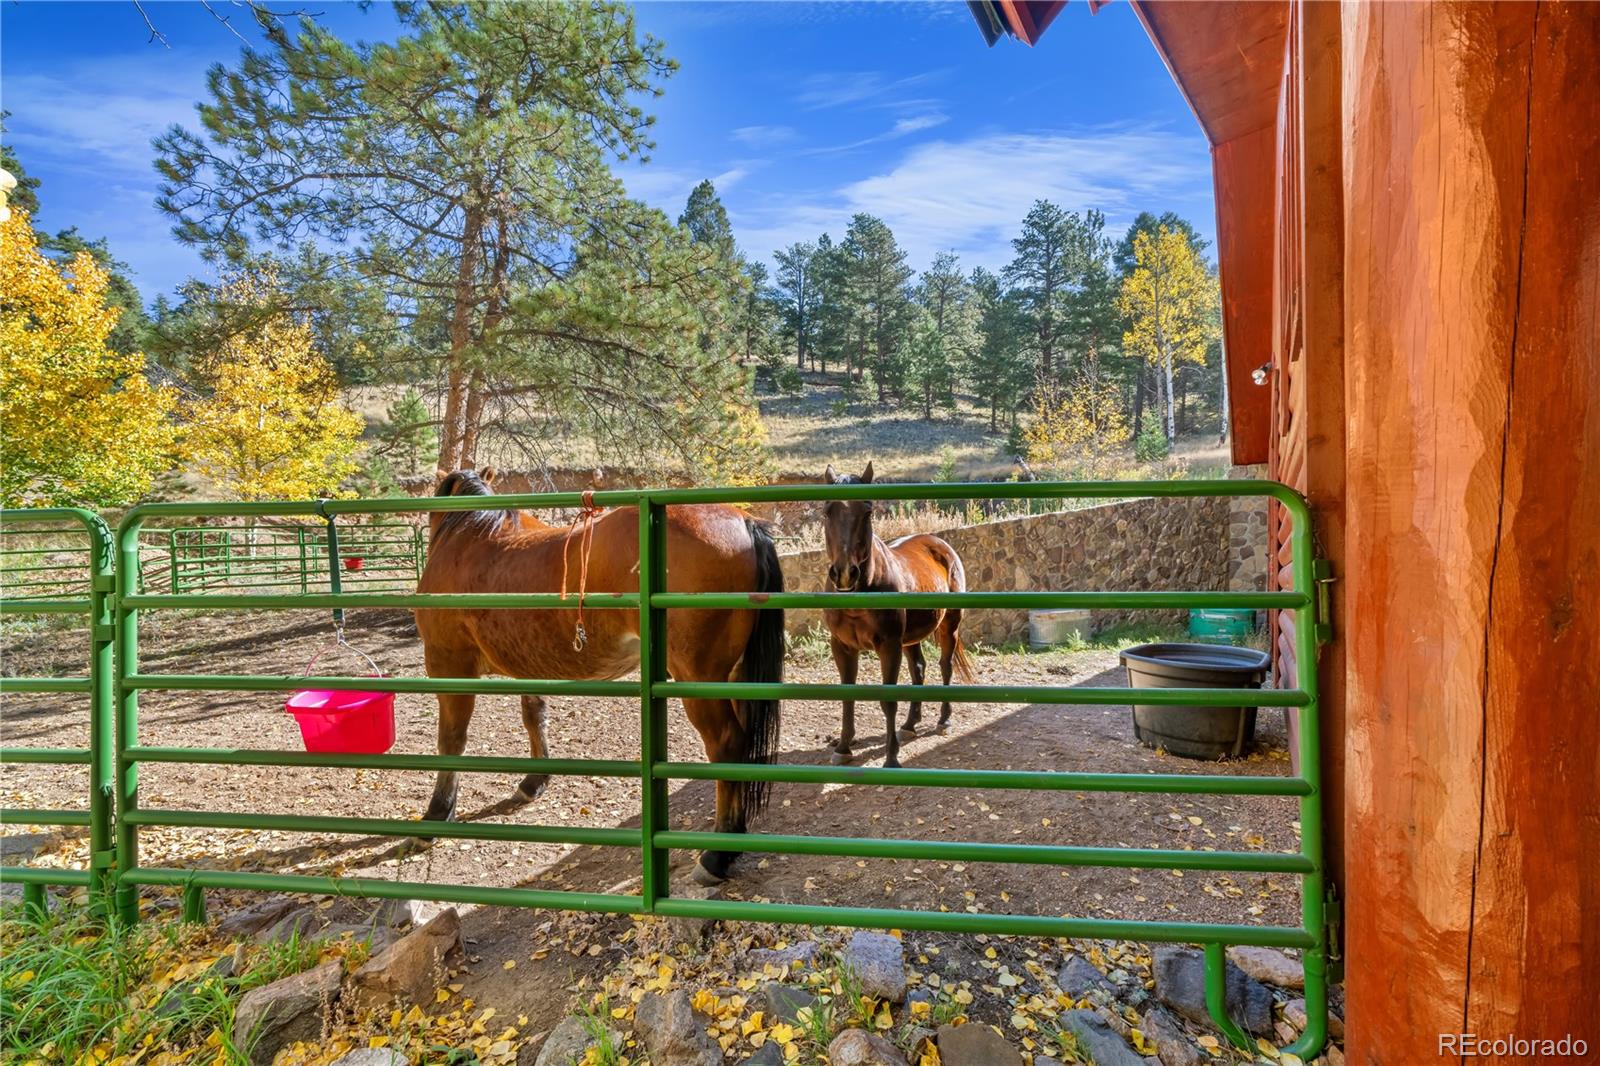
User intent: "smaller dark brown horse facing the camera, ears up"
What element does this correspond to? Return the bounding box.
[822,463,973,767]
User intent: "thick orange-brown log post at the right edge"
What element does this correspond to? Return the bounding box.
[1342,3,1600,1063]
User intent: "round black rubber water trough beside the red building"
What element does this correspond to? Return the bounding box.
[1122,643,1272,759]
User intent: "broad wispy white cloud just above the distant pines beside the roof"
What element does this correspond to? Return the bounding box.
[733,126,1211,267]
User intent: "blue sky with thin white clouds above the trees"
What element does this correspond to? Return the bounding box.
[0,0,1214,301]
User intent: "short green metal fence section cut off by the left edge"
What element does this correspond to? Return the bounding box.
[0,507,115,911]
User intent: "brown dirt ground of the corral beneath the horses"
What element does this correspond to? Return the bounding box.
[0,611,1299,1026]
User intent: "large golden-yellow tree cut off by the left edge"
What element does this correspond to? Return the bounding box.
[0,208,174,506]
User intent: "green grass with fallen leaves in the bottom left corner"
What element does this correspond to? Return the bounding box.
[0,906,345,1063]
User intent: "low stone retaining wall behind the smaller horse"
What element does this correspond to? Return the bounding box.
[782,499,1228,643]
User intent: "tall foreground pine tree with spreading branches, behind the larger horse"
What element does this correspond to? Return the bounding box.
[157,2,739,472]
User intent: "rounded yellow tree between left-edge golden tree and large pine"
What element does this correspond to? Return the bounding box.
[186,270,363,499]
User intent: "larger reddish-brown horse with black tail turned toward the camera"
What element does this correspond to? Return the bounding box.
[416,469,784,884]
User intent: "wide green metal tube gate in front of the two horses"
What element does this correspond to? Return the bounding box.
[0,480,1330,1058]
